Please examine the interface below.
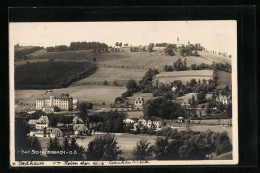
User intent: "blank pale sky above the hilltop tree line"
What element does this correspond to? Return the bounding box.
[9,20,237,55]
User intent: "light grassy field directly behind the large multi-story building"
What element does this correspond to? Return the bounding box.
[15,85,126,104]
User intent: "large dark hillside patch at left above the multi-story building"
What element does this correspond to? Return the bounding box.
[15,62,96,89]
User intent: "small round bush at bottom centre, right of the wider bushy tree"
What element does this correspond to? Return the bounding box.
[133,139,152,160]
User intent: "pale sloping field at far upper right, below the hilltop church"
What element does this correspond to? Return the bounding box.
[199,51,232,64]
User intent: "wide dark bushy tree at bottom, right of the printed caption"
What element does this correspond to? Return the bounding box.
[86,135,121,161]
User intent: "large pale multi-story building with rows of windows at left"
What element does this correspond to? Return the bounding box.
[36,94,73,111]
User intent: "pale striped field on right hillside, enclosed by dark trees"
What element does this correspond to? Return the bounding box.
[154,70,213,84]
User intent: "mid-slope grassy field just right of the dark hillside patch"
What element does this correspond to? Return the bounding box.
[75,68,145,85]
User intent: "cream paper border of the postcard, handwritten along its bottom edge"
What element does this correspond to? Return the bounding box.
[9,20,239,167]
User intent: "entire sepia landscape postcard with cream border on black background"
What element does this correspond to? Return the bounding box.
[9,20,239,167]
